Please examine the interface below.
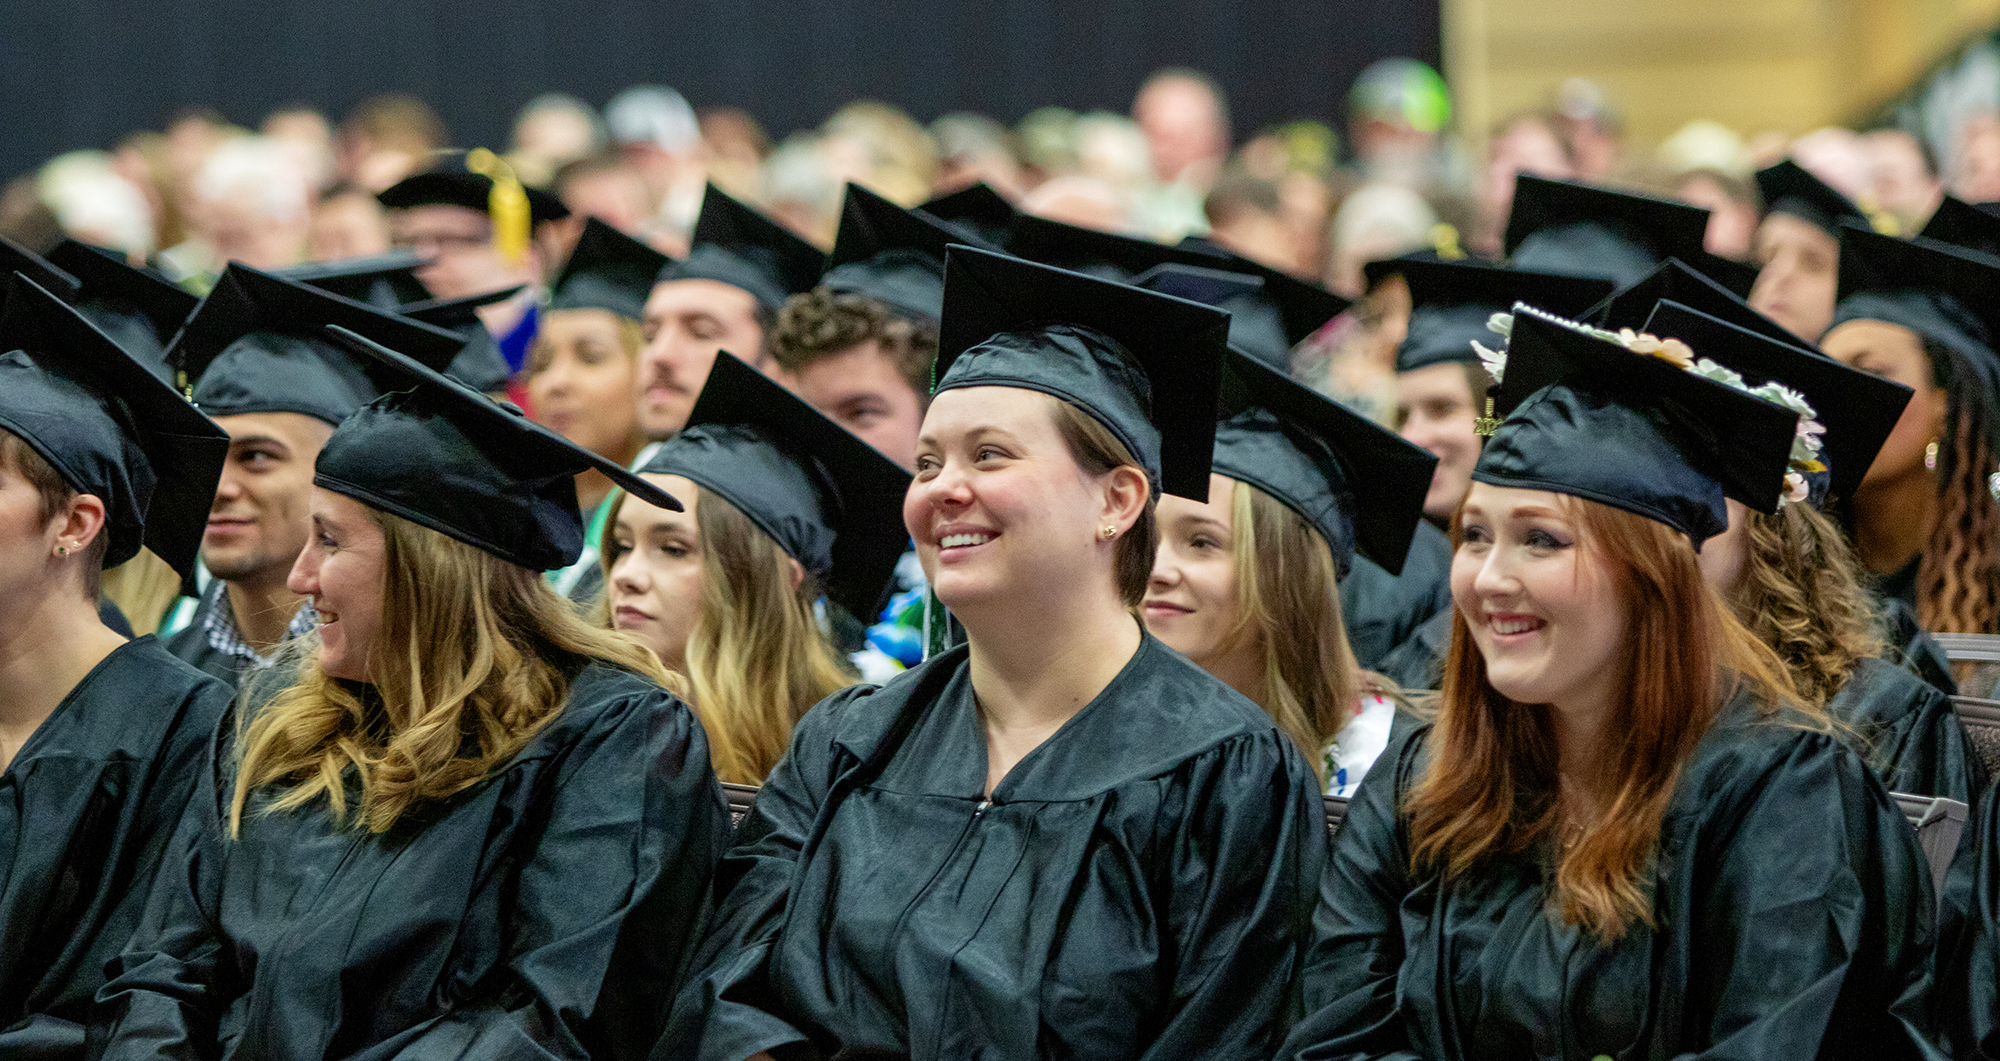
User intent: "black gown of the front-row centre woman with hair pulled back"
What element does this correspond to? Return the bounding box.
[654,637,1326,1061]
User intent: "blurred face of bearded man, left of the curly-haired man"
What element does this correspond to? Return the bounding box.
[638,280,764,438]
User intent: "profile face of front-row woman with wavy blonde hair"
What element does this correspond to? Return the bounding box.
[286,486,388,681]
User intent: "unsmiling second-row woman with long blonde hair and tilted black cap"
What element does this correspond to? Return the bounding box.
[602,352,910,785]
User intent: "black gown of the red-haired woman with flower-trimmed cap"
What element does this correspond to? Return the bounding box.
[1280,699,1942,1061]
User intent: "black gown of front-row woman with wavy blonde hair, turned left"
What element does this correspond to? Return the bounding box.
[100,663,728,1061]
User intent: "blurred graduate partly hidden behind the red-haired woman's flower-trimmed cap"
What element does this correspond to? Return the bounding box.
[1340,254,1612,689]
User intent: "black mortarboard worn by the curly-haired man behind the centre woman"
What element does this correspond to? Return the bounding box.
[820,182,988,320]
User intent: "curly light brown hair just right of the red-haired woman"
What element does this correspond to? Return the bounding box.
[1730,504,1882,705]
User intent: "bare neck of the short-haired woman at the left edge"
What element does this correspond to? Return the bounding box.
[0,587,126,771]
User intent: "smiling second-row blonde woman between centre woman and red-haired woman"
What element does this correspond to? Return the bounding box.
[1142,322,1436,797]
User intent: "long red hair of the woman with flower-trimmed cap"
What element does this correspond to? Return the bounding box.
[1406,496,1832,941]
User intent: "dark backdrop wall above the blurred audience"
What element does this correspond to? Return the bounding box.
[0,0,1440,180]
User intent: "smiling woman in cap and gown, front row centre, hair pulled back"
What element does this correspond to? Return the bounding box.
[654,246,1326,1061]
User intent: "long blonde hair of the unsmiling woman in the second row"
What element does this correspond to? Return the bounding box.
[598,486,844,785]
